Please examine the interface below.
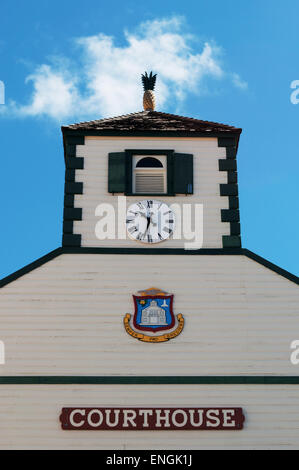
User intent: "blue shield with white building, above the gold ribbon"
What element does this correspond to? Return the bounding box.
[133,288,175,333]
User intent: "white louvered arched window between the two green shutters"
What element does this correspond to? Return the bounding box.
[132,155,167,194]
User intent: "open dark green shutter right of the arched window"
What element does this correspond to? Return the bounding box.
[173,153,193,194]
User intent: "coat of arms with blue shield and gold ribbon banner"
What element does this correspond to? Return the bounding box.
[124,287,184,343]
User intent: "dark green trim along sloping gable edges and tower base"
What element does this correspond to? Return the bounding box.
[0,246,299,287]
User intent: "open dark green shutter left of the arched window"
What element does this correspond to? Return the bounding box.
[108,152,126,193]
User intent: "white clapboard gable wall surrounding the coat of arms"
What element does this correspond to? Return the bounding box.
[0,254,299,376]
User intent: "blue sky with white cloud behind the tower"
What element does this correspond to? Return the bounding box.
[0,0,299,277]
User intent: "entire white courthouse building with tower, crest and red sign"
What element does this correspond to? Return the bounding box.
[0,80,299,449]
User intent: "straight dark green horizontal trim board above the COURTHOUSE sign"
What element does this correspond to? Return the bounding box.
[0,375,299,385]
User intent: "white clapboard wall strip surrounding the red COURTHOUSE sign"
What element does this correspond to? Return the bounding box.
[0,385,299,450]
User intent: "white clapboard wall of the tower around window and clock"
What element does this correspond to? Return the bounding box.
[74,137,230,248]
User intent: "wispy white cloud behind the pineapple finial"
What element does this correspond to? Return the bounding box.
[4,17,247,120]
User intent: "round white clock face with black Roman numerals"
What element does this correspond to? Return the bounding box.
[126,199,174,243]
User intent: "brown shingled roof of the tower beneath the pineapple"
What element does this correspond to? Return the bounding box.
[62,111,242,134]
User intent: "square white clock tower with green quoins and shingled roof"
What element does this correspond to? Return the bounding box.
[62,110,241,250]
